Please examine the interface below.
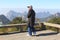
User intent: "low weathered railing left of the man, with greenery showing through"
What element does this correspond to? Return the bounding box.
[0,23,39,34]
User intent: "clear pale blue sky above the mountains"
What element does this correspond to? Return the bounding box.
[0,0,60,14]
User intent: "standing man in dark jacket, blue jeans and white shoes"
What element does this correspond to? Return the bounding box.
[27,6,36,36]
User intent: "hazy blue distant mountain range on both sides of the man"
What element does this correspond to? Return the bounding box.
[7,10,52,21]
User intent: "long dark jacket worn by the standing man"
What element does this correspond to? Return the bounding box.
[27,9,35,26]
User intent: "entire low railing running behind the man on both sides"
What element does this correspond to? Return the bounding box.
[0,22,60,34]
